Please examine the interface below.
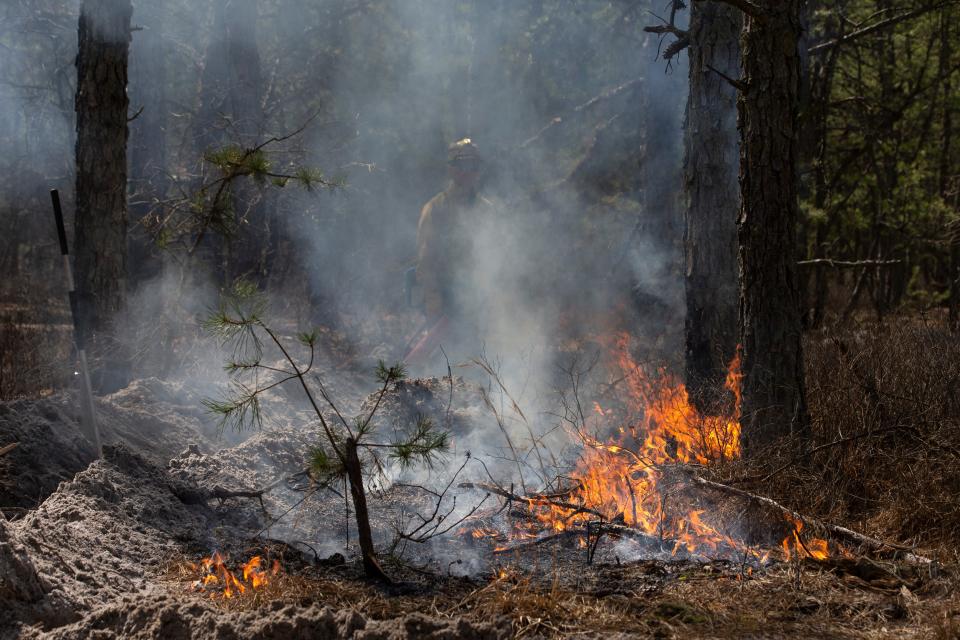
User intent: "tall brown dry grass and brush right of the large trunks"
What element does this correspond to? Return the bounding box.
[713,317,960,563]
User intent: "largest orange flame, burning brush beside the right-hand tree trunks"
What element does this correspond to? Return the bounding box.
[530,333,743,552]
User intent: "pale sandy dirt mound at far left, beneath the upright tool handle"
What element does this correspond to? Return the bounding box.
[0,445,212,628]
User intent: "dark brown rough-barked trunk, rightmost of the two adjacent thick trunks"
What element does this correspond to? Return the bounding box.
[737,5,809,455]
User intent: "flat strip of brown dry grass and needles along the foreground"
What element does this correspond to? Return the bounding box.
[166,548,960,640]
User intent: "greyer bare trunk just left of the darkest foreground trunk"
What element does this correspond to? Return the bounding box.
[684,2,742,410]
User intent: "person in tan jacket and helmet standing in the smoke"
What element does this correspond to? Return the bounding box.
[405,138,490,364]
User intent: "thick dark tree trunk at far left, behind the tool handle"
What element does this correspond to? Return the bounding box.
[75,0,133,390]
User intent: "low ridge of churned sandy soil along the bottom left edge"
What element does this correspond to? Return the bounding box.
[38,597,510,640]
